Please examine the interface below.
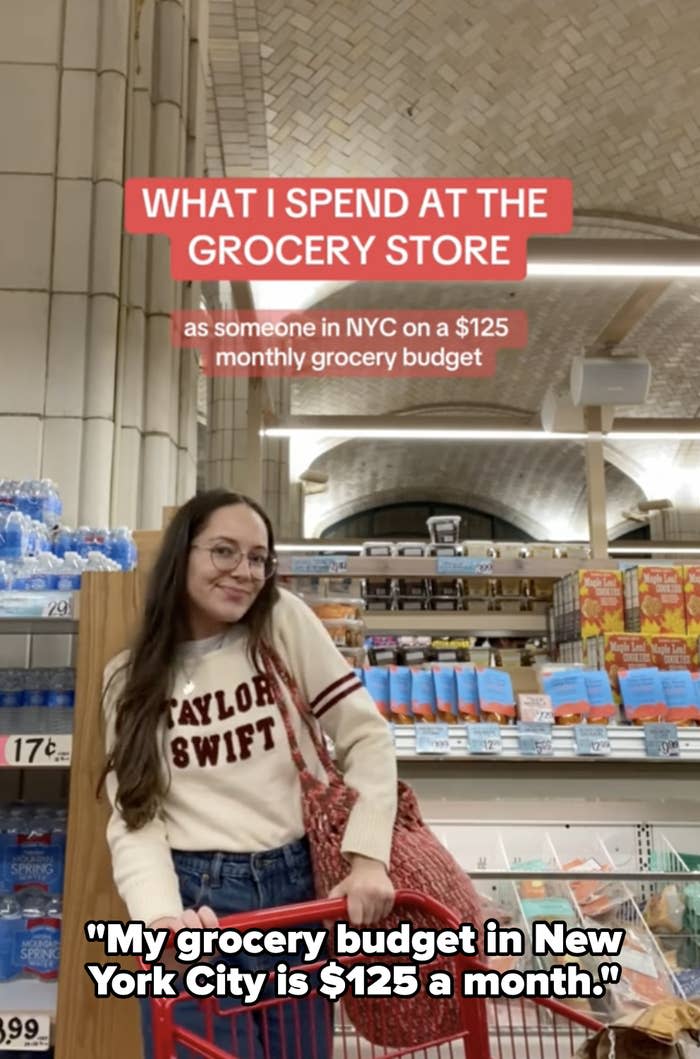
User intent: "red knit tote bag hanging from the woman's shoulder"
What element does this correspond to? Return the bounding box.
[263,648,483,1048]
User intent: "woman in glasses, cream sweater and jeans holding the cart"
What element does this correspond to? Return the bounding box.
[98,490,396,1059]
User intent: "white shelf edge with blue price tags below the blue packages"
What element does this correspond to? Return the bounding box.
[394,724,700,768]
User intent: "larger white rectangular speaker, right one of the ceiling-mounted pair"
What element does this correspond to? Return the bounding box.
[570,357,651,407]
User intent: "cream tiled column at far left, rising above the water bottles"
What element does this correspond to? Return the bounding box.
[0,0,208,527]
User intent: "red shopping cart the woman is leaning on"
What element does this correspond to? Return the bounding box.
[144,891,603,1059]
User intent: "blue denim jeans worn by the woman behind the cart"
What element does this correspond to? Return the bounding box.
[141,840,333,1059]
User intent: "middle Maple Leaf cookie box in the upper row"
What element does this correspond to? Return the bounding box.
[625,564,686,636]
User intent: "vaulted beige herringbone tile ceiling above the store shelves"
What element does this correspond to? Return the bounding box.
[207,0,700,537]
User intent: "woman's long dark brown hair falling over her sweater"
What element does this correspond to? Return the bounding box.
[97,489,279,830]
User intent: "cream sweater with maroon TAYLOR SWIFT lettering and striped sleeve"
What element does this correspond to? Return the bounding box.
[105,589,396,923]
